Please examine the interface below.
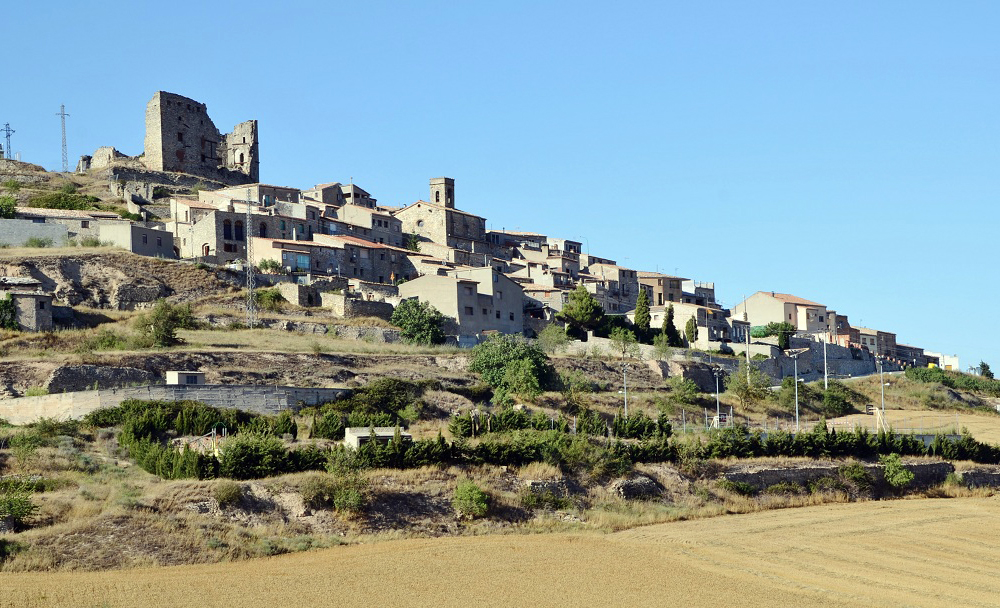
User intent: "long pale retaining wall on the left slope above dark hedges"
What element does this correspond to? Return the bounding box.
[0,384,351,425]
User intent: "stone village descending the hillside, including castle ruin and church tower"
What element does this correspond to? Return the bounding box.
[0,91,959,378]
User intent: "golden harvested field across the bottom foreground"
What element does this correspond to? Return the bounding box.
[0,498,1000,607]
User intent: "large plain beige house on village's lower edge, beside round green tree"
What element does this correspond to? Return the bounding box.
[399,267,524,336]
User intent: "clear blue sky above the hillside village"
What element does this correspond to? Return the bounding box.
[0,0,1000,367]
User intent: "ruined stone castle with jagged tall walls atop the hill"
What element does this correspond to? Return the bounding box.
[77,91,260,186]
